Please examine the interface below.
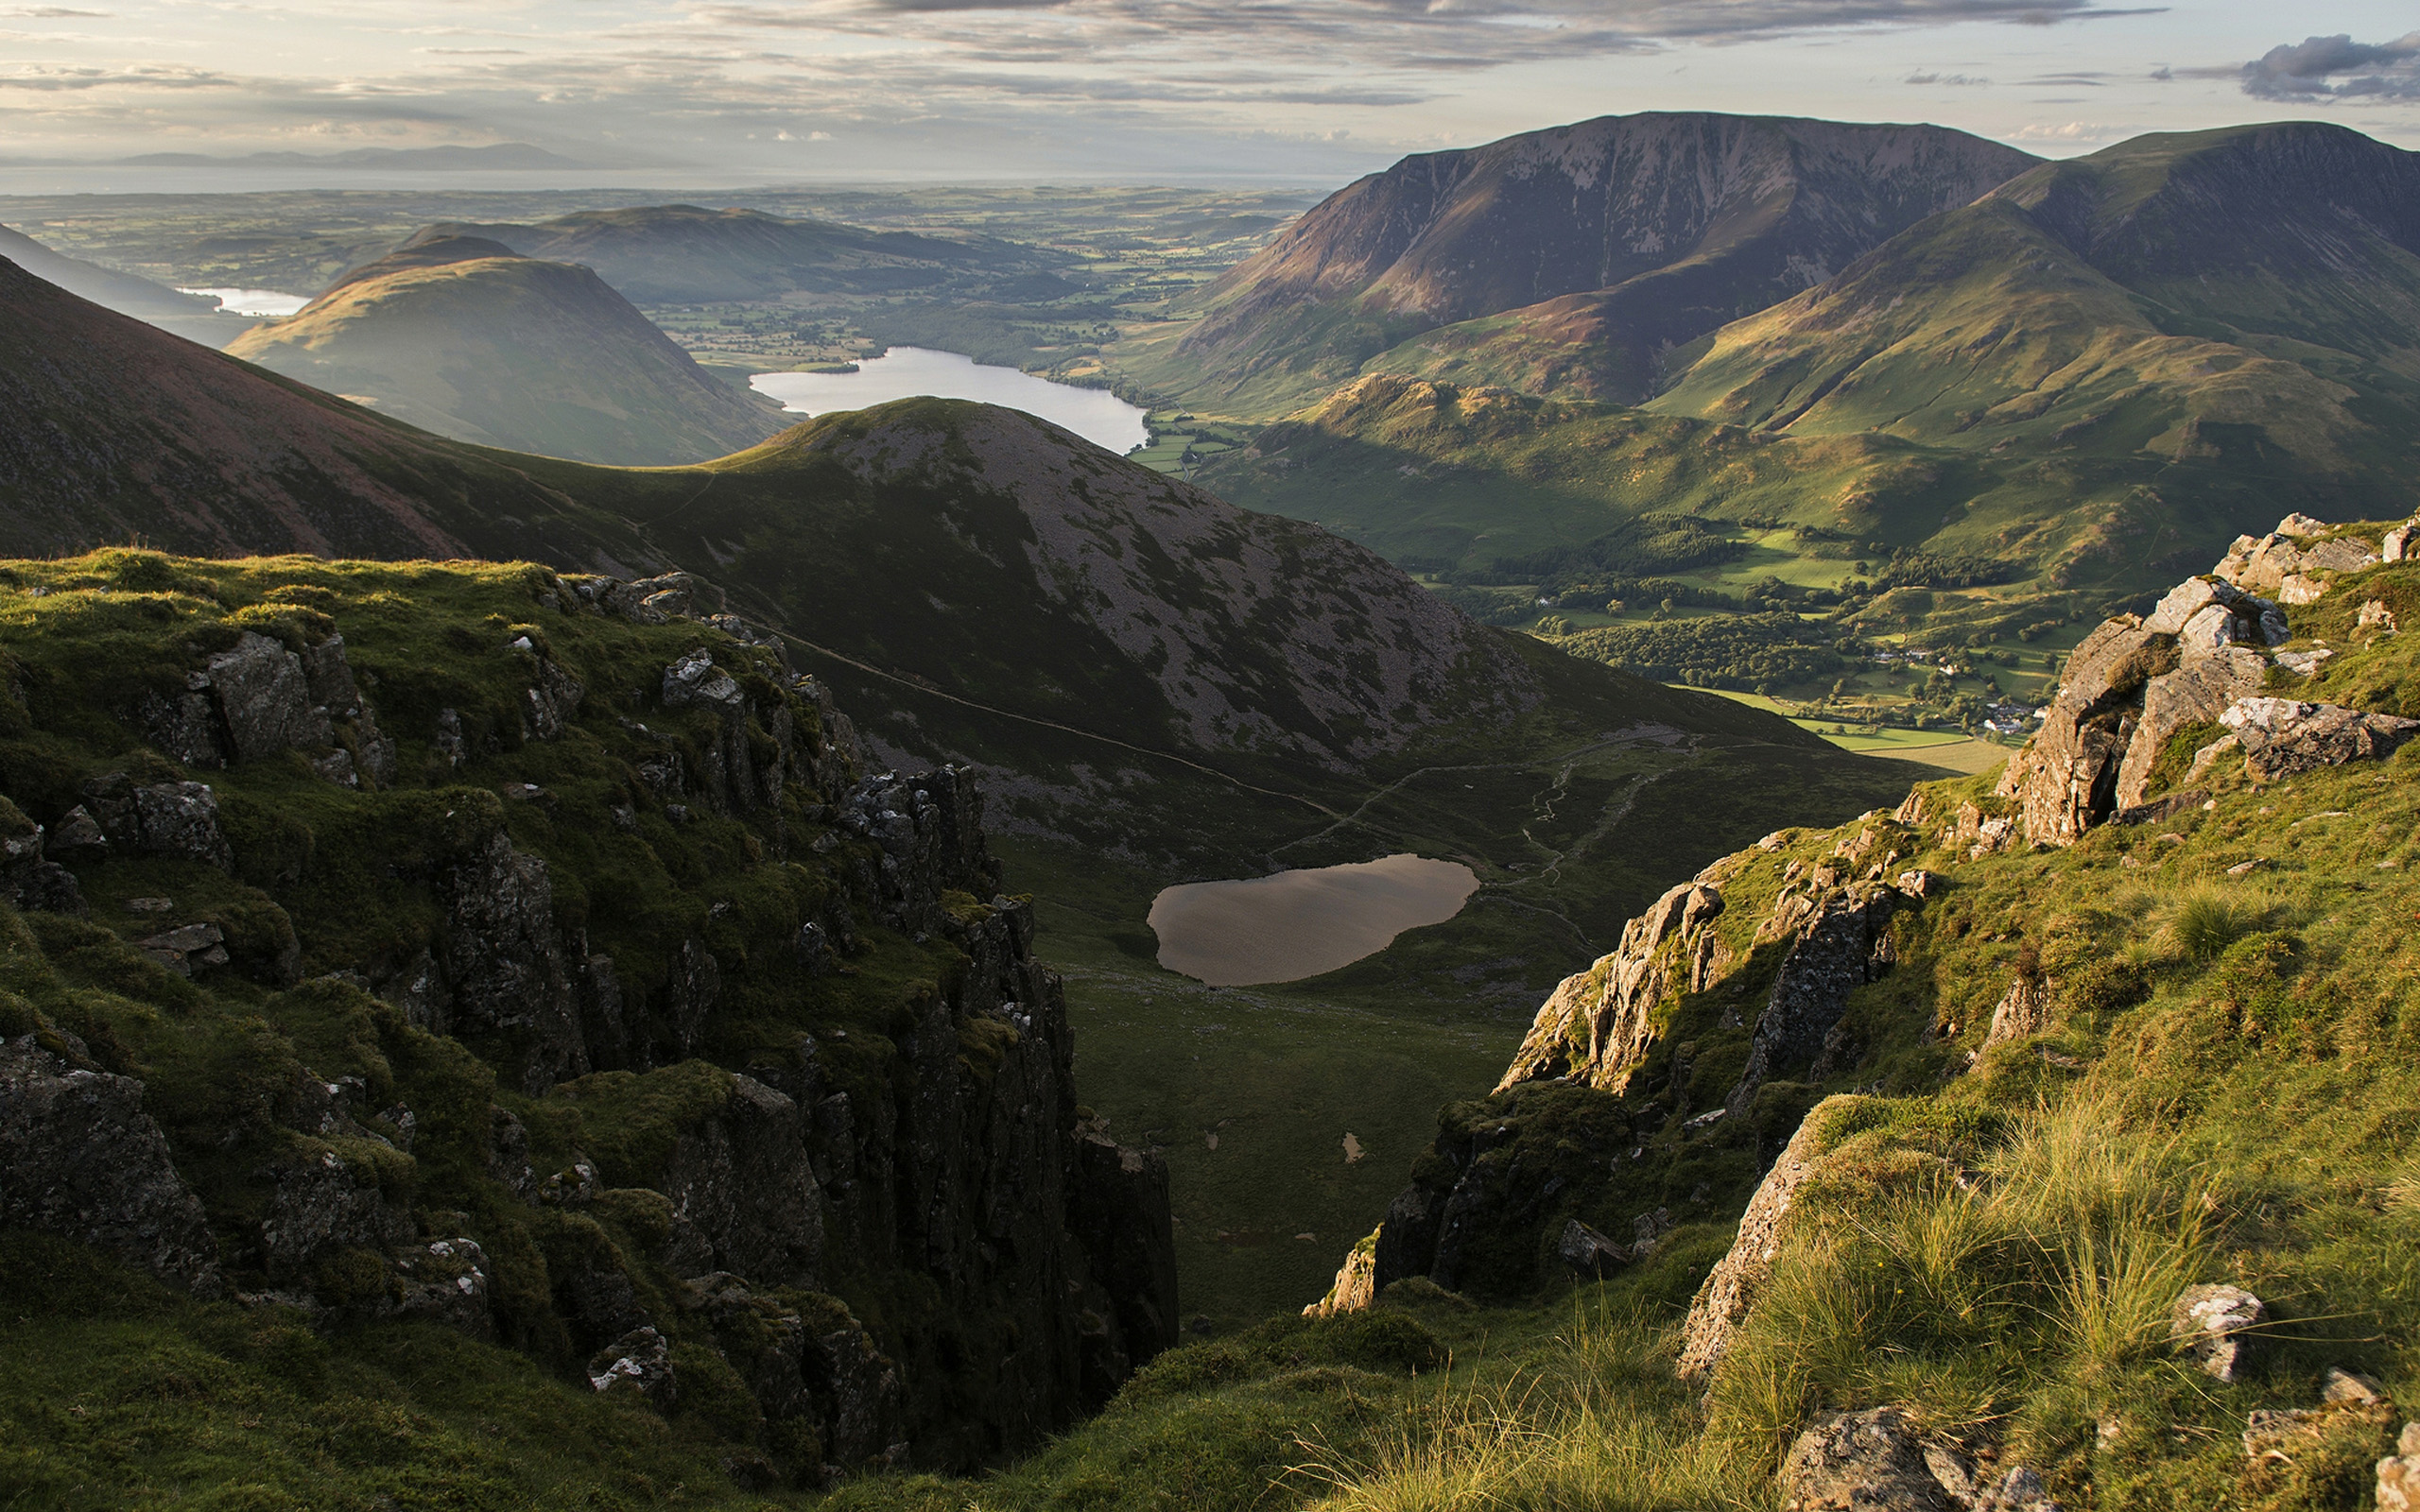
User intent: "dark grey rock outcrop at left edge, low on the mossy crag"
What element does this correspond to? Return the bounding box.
[0,1036,220,1297]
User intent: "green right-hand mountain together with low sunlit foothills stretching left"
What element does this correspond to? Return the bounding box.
[1202,126,2420,636]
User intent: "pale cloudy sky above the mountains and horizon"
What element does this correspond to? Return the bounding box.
[0,0,2420,189]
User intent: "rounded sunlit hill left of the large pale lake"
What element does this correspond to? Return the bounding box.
[228,237,782,467]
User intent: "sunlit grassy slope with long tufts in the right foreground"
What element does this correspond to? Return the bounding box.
[808,551,2420,1512]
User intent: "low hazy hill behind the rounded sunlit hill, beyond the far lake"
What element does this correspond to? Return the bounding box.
[421,206,1047,305]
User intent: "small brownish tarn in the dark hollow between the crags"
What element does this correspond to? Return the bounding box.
[1152,851,1478,987]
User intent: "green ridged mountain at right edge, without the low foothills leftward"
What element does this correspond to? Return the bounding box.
[1651,124,2420,476]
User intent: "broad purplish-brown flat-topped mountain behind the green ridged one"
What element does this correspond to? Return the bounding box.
[1132,113,2038,416]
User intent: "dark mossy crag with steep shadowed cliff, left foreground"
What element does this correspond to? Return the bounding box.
[0,552,1176,1483]
